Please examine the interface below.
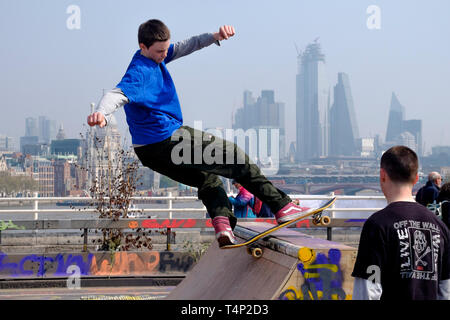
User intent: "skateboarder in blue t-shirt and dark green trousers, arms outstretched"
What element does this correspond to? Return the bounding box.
[87,19,310,246]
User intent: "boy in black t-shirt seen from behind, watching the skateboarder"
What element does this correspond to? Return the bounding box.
[352,146,450,300]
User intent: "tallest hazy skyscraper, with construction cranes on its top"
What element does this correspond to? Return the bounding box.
[296,40,329,161]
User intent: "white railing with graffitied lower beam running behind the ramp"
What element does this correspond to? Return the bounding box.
[0,194,386,251]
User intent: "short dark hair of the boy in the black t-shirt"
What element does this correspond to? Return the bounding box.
[380,146,419,183]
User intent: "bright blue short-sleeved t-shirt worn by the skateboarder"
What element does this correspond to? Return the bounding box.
[117,44,183,145]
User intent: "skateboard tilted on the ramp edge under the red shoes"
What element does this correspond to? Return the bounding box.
[221,198,336,258]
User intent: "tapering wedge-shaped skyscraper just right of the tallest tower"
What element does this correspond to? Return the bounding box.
[329,72,359,156]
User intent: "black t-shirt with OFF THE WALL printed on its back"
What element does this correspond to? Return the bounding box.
[352,201,450,300]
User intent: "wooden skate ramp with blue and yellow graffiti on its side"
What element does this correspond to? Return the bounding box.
[167,222,356,300]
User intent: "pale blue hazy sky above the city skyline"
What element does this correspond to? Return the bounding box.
[0,0,450,154]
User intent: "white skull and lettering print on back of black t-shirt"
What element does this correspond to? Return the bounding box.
[394,220,440,280]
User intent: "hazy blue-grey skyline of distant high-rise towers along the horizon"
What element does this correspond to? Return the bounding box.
[0,63,439,162]
